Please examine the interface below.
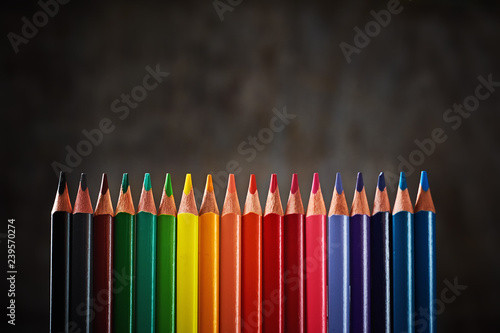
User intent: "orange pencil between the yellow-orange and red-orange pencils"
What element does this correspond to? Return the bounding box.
[220,174,241,333]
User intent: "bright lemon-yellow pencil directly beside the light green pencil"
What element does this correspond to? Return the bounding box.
[176,174,198,333]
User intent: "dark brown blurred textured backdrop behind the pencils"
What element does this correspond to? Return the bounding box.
[0,0,500,332]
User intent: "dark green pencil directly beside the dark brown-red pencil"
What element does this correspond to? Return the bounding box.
[113,173,136,333]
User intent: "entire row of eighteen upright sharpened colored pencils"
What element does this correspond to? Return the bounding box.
[50,172,436,333]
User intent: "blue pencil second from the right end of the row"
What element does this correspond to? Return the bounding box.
[392,172,415,333]
